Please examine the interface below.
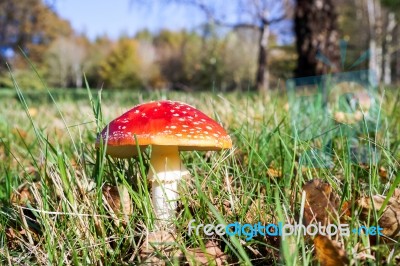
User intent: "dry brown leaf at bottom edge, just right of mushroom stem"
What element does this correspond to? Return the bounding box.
[186,241,228,266]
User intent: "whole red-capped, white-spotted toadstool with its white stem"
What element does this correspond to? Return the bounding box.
[96,101,232,228]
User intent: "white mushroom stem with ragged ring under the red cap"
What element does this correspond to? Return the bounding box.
[149,145,188,227]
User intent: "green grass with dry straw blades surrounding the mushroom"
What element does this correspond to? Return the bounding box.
[0,80,400,265]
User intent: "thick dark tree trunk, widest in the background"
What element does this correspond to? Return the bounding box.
[295,0,340,77]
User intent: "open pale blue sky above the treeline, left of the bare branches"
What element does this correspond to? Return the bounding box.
[54,0,205,39]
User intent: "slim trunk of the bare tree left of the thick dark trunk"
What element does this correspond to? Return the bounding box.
[256,23,270,93]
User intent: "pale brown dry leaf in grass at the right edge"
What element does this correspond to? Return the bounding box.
[357,188,400,237]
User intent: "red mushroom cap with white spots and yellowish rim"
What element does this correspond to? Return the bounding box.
[96,101,232,158]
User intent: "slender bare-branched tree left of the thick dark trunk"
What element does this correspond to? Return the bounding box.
[164,0,291,92]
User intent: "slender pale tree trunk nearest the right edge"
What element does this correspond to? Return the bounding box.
[383,12,396,85]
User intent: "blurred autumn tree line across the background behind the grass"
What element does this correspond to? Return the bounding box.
[0,0,400,91]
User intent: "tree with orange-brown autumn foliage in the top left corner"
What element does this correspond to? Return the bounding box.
[0,0,73,70]
